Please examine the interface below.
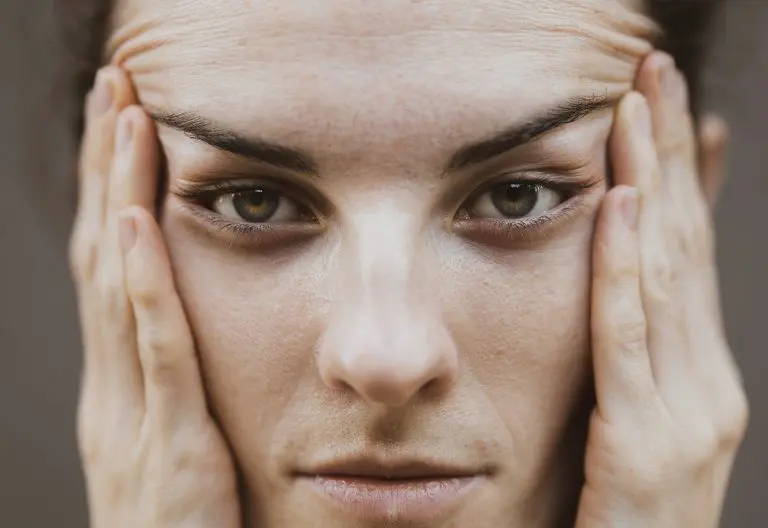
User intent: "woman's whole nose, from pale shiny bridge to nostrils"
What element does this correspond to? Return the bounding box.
[318,207,457,407]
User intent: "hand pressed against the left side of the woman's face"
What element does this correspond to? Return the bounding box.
[70,67,241,528]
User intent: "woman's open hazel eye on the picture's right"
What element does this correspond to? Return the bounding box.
[465,182,566,220]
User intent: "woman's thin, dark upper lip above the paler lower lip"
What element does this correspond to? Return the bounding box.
[299,457,488,479]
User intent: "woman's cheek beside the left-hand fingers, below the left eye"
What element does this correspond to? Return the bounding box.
[163,214,328,463]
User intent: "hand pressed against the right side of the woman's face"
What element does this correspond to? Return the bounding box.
[576,53,748,528]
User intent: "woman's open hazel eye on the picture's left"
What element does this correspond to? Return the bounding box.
[211,187,304,224]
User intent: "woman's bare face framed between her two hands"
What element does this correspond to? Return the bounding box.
[110,0,653,528]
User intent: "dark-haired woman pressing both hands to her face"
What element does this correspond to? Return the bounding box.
[63,0,747,528]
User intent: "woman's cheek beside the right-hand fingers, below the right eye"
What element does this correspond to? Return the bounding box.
[443,218,592,458]
